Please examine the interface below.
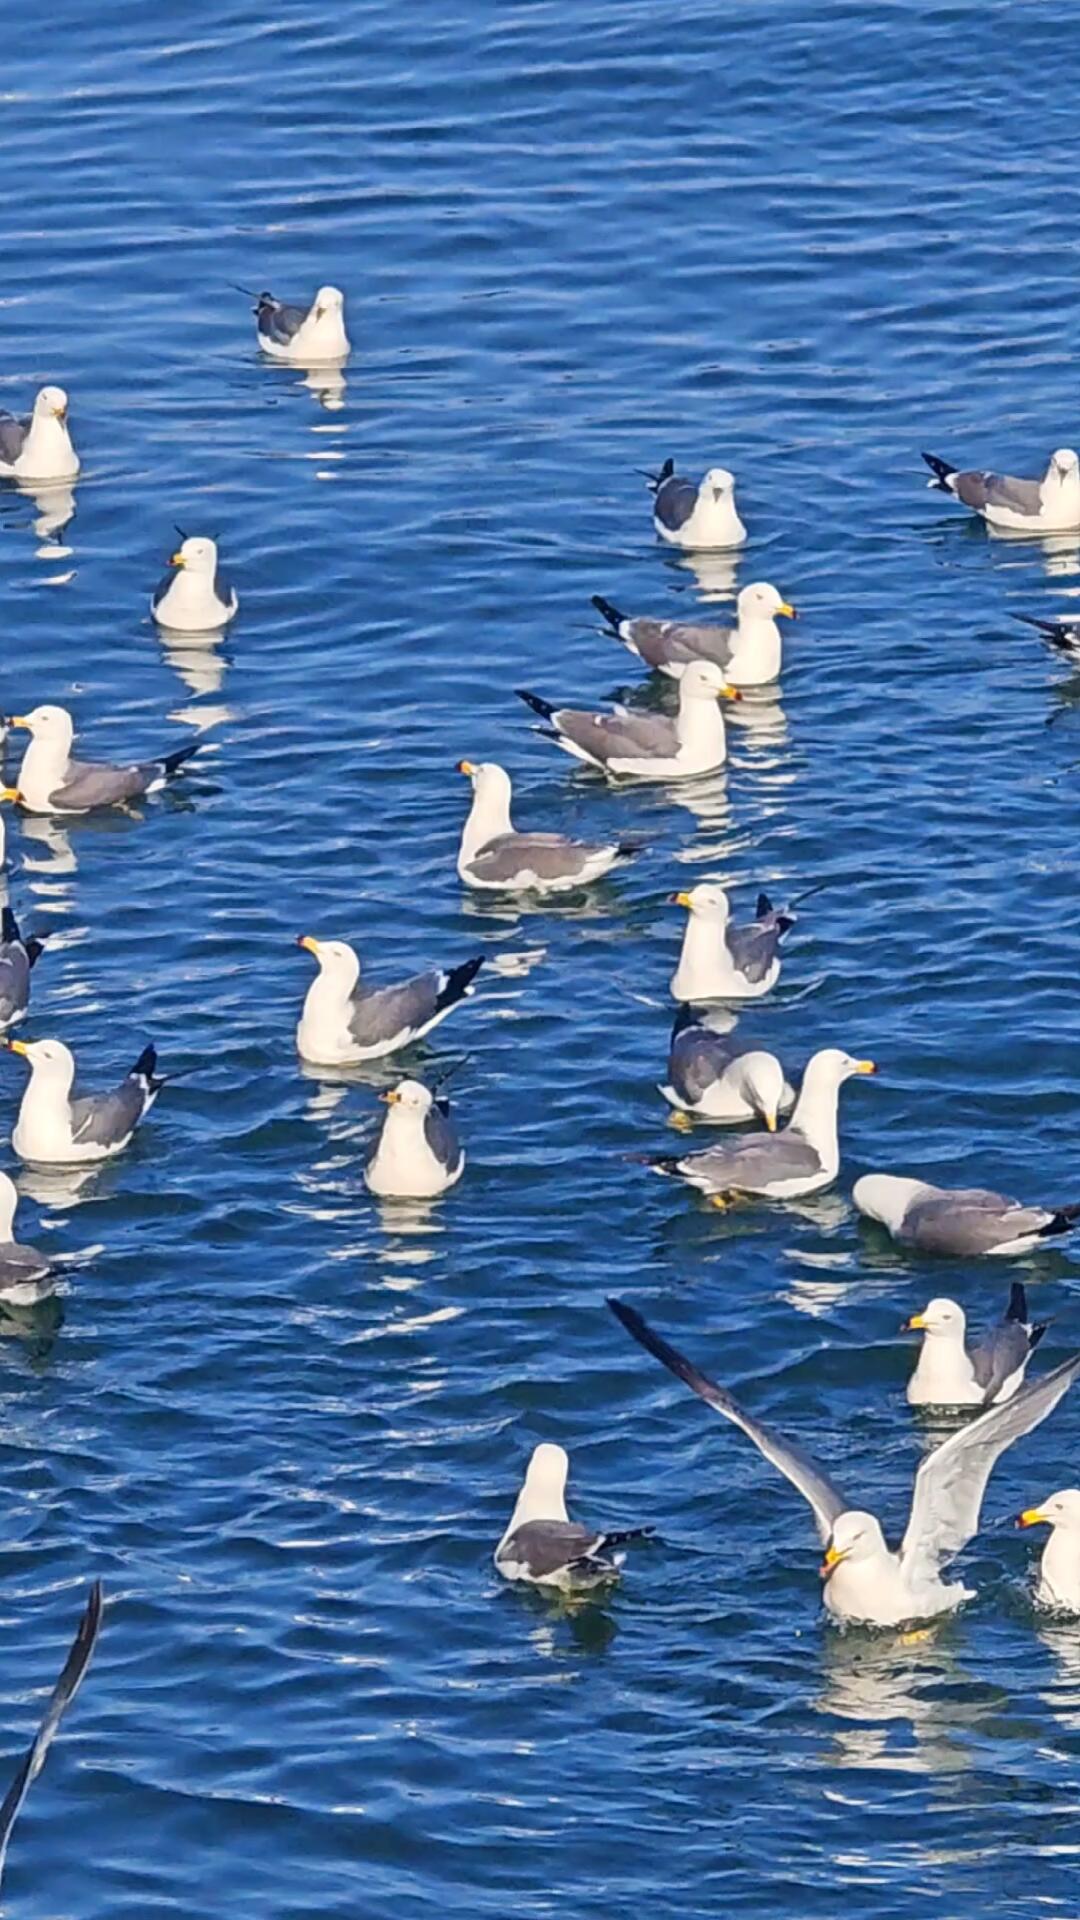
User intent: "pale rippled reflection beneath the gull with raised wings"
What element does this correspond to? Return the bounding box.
[813,1626,1005,1774]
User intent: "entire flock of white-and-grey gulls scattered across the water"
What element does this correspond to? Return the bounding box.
[0,286,1080,1872]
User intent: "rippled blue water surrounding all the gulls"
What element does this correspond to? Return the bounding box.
[0,0,1080,1920]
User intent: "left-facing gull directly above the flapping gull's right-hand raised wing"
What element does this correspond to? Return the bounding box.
[901,1281,1045,1407]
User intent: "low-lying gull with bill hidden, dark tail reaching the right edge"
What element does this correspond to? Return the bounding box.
[851,1173,1080,1260]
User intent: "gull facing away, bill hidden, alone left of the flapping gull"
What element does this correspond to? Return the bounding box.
[496,1442,653,1594]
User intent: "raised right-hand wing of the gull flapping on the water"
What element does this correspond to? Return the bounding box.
[899,1354,1080,1584]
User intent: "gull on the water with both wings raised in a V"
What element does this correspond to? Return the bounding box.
[607,1300,1080,1626]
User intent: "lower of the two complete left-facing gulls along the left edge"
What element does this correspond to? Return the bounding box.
[0,1041,177,1167]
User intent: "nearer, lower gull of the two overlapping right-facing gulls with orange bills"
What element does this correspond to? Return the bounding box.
[517,660,738,780]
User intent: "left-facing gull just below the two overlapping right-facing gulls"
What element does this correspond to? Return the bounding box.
[457,760,642,893]
